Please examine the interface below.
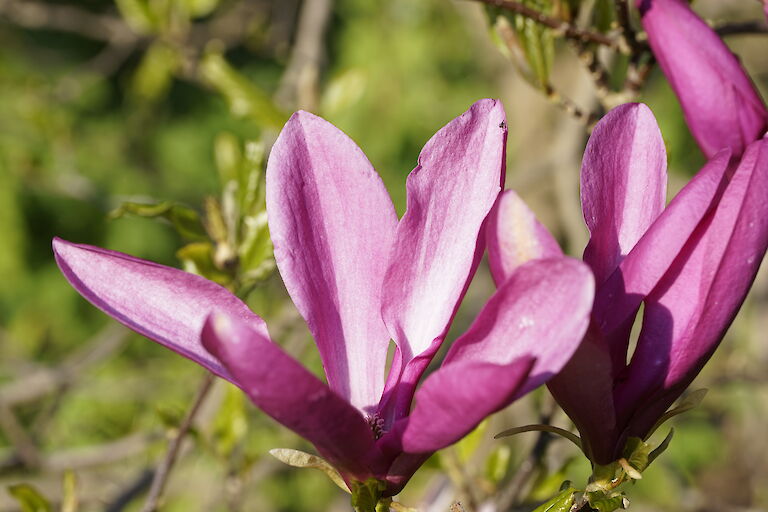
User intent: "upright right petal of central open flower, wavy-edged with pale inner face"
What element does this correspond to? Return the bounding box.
[382,100,507,415]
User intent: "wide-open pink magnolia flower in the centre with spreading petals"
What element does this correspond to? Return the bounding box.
[54,100,594,496]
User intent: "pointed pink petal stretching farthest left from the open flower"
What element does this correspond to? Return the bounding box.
[53,238,269,384]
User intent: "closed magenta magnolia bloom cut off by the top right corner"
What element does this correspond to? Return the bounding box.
[637,0,768,158]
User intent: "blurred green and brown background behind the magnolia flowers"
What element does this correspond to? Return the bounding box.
[0,0,768,512]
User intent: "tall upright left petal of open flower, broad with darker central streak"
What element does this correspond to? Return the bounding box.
[267,112,397,410]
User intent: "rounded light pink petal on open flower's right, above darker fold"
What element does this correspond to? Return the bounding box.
[445,257,595,397]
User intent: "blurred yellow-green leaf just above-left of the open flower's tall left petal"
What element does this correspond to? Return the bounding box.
[200,52,288,129]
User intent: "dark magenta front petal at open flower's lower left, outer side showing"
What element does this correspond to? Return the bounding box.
[202,313,374,481]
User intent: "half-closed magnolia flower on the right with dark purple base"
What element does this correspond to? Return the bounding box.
[488,104,768,464]
